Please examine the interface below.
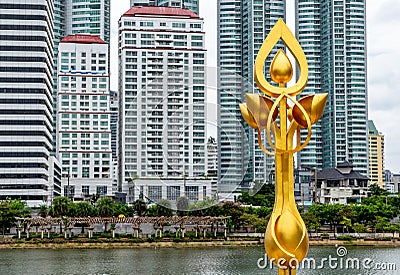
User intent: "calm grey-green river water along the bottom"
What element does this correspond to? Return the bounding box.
[0,246,400,275]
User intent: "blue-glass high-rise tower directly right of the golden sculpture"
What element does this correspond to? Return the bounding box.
[296,0,368,175]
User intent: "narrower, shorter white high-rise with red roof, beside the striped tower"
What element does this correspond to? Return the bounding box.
[57,34,113,200]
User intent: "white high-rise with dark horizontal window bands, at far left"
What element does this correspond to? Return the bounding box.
[0,0,60,206]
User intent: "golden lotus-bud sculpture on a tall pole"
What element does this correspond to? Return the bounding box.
[240,19,328,275]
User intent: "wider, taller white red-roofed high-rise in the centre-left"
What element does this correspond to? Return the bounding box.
[118,7,210,205]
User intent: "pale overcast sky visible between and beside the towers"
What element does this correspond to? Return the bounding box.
[111,0,400,173]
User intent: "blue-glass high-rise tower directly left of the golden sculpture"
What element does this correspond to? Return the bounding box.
[217,0,286,198]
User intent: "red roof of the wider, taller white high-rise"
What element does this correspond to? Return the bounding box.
[123,6,200,19]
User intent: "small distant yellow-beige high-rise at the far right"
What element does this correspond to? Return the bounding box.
[368,120,386,188]
